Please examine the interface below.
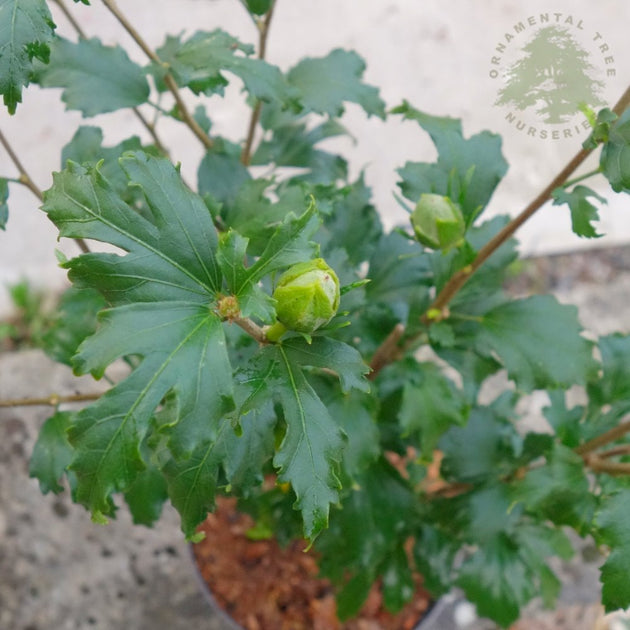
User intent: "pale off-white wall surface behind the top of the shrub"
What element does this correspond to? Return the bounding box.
[0,0,630,311]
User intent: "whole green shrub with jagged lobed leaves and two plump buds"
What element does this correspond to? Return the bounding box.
[0,0,630,626]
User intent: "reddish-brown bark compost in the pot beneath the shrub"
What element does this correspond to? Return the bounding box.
[191,499,446,630]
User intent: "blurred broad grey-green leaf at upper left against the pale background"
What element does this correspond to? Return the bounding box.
[38,38,149,117]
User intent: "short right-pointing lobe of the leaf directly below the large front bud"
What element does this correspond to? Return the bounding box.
[282,337,370,394]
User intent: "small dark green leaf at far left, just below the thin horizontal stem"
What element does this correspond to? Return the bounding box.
[28,411,74,494]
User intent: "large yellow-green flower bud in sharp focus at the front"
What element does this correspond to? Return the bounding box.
[273,258,339,333]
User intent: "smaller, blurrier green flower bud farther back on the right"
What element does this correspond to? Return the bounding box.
[411,194,466,250]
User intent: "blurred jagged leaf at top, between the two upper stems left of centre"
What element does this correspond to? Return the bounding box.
[157,29,297,106]
